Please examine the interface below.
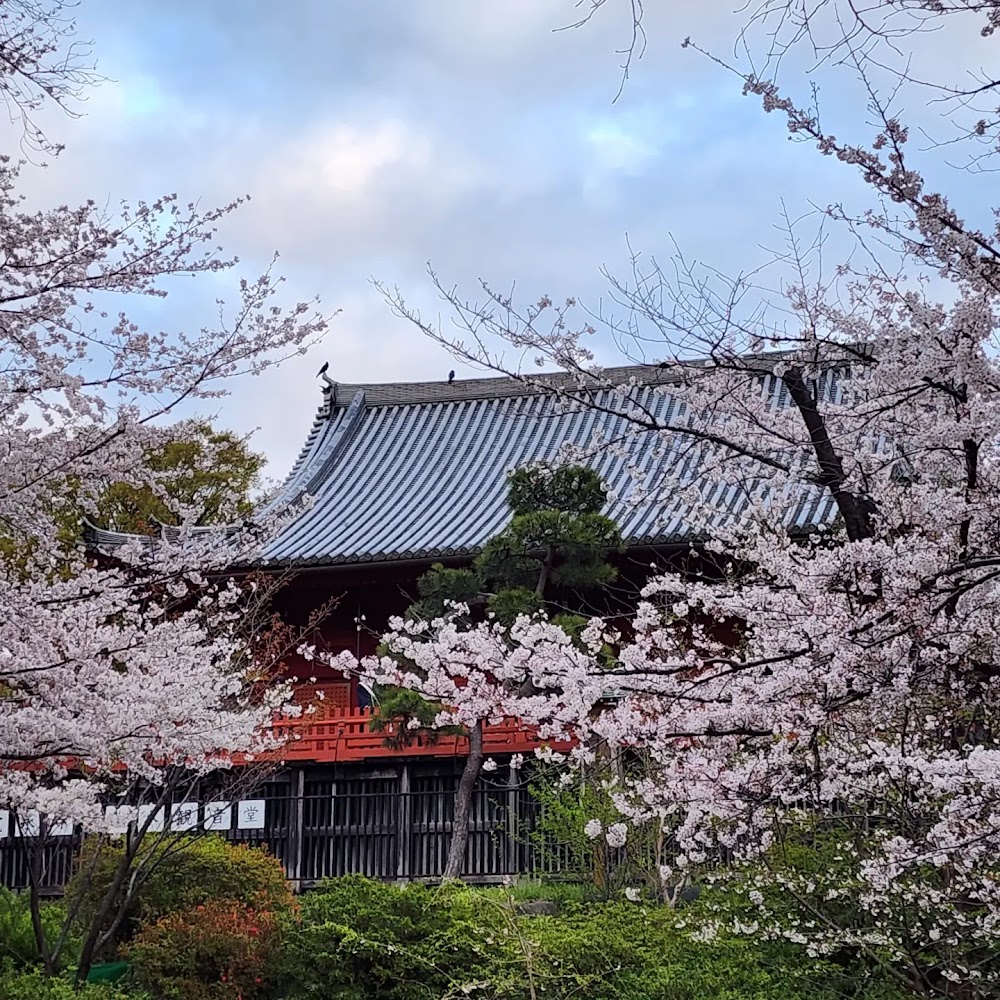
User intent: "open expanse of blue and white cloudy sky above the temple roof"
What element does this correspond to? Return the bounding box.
[11,0,988,484]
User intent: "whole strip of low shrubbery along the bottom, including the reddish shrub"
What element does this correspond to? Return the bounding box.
[0,876,906,1000]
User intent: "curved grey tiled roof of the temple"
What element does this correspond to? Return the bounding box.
[86,367,833,566]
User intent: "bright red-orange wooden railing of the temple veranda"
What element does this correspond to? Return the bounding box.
[274,708,572,764]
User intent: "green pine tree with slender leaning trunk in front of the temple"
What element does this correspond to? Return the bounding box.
[374,466,621,878]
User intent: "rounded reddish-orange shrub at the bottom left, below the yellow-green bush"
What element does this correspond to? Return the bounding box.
[125,900,280,1000]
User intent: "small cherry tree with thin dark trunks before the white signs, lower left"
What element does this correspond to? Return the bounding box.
[23,560,310,980]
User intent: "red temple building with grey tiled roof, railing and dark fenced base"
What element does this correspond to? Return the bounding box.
[0,366,832,886]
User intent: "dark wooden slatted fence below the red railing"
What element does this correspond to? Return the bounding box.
[0,767,580,893]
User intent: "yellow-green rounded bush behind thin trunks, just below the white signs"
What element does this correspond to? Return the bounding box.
[66,835,292,940]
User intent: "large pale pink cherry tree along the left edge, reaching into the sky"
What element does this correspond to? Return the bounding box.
[0,0,327,975]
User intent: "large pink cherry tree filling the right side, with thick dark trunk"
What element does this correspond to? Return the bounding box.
[380,0,1000,997]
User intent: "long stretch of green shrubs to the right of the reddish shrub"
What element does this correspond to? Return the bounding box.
[281,876,905,1000]
